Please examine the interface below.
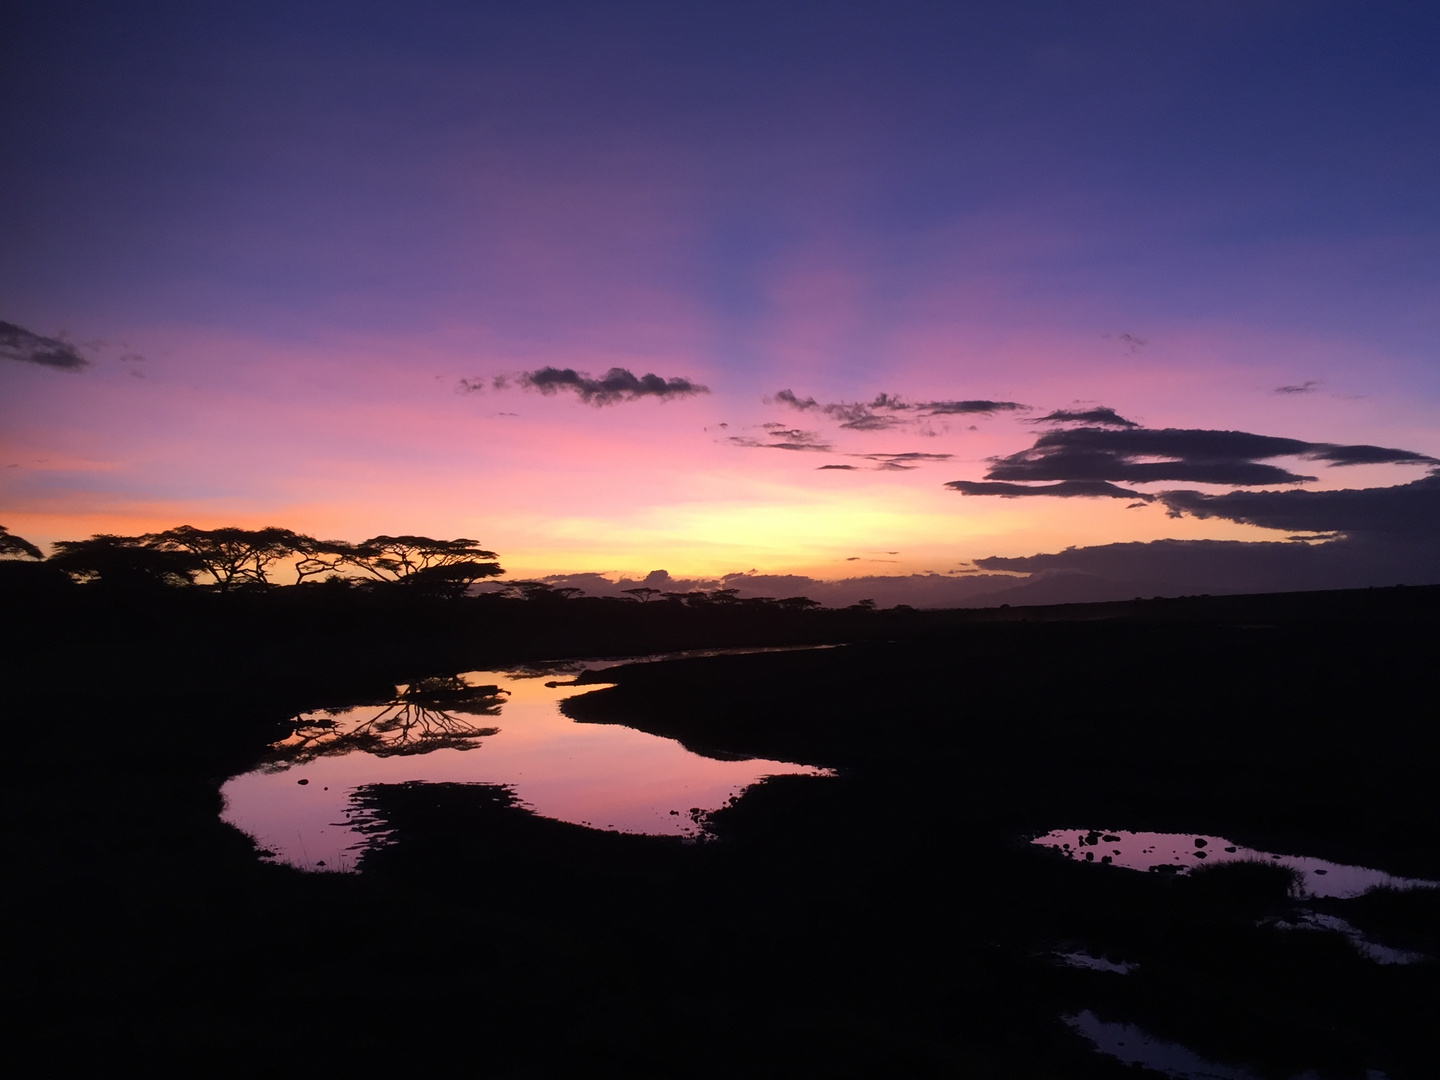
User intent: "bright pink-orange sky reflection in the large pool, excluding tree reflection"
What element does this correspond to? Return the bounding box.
[222,664,825,870]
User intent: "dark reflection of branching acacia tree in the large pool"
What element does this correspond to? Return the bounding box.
[262,675,510,772]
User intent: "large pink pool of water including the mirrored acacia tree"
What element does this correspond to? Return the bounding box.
[220,649,829,870]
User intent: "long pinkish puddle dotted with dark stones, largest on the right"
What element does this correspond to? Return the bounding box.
[1032,829,1440,899]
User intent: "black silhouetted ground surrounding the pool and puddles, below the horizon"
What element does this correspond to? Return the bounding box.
[3,576,1440,1080]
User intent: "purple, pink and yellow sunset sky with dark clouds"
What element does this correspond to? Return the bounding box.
[0,0,1440,602]
